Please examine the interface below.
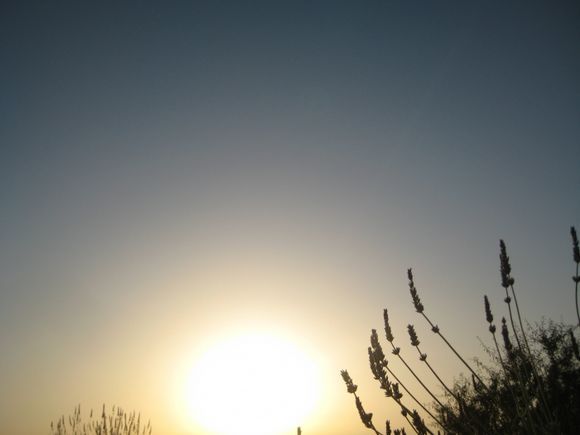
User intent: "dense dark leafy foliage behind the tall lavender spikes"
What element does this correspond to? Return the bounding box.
[436,322,580,434]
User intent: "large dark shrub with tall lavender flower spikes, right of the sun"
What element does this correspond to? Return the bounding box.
[341,227,580,435]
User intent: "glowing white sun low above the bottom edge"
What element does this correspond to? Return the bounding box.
[186,334,320,435]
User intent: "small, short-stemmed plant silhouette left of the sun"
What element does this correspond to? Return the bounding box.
[50,405,152,435]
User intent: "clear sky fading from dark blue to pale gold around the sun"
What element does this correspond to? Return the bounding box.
[0,0,580,435]
